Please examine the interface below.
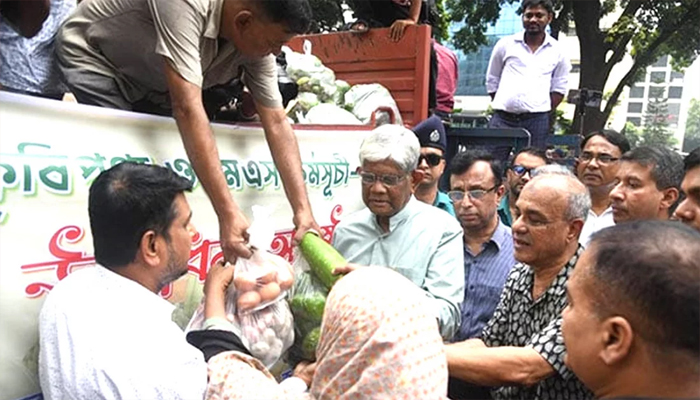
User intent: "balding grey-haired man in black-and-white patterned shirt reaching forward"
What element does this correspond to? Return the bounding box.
[445,171,593,400]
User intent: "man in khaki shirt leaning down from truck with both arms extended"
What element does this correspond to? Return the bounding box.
[56,0,319,261]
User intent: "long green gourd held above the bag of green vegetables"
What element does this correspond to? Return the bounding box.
[299,232,347,290]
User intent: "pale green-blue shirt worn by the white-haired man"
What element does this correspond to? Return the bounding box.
[333,197,464,339]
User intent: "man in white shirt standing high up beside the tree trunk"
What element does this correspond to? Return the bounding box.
[486,0,571,149]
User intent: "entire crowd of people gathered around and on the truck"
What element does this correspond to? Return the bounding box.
[0,0,700,399]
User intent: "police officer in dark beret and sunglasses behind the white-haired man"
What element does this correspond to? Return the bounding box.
[413,115,455,217]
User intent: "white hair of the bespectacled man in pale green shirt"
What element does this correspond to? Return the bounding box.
[360,124,420,173]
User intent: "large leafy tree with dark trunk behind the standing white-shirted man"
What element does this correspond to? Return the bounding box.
[447,0,700,132]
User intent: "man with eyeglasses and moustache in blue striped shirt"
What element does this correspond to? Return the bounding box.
[448,150,515,399]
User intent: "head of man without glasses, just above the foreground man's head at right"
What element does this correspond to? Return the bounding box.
[610,146,683,224]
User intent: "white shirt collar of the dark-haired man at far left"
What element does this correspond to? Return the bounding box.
[95,265,175,318]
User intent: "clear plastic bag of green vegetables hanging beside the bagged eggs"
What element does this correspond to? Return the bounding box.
[288,247,328,363]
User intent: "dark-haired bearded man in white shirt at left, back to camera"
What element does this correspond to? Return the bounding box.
[39,163,207,400]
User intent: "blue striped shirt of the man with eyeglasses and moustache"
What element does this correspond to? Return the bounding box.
[455,221,516,341]
